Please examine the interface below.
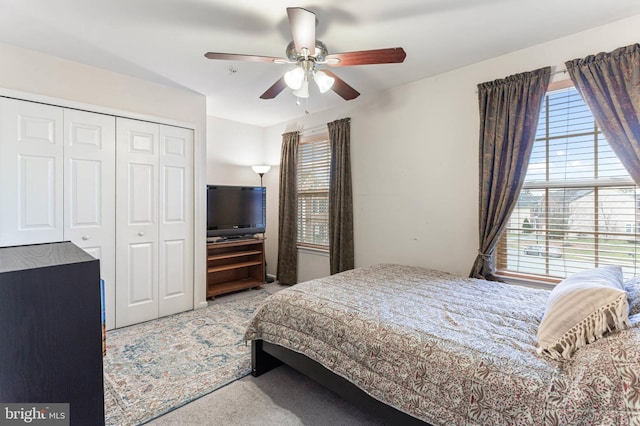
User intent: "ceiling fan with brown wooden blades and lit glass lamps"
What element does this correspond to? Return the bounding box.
[204,7,407,101]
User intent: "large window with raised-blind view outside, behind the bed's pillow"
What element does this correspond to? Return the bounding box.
[496,87,640,281]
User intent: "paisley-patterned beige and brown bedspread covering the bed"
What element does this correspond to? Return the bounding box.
[245,265,640,425]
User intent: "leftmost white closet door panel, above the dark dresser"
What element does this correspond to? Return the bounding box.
[0,98,63,246]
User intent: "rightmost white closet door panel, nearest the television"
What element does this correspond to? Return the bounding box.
[158,125,193,316]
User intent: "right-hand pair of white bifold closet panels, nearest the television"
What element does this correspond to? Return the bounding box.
[116,118,193,327]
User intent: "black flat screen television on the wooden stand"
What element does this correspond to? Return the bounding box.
[207,185,267,238]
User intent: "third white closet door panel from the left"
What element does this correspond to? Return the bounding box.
[116,118,159,327]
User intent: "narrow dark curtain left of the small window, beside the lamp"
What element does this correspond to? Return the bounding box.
[277,131,300,285]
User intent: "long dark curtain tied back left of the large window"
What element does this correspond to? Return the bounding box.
[470,67,551,280]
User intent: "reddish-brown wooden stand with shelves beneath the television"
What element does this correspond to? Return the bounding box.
[207,238,266,298]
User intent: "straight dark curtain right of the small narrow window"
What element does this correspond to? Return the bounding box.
[327,118,354,275]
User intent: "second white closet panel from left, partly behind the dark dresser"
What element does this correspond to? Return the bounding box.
[64,109,116,329]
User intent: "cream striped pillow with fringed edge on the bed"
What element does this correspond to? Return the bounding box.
[538,266,630,360]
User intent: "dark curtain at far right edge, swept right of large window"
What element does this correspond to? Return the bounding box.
[565,43,640,185]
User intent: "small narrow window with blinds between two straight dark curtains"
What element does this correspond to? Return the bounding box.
[298,135,331,249]
